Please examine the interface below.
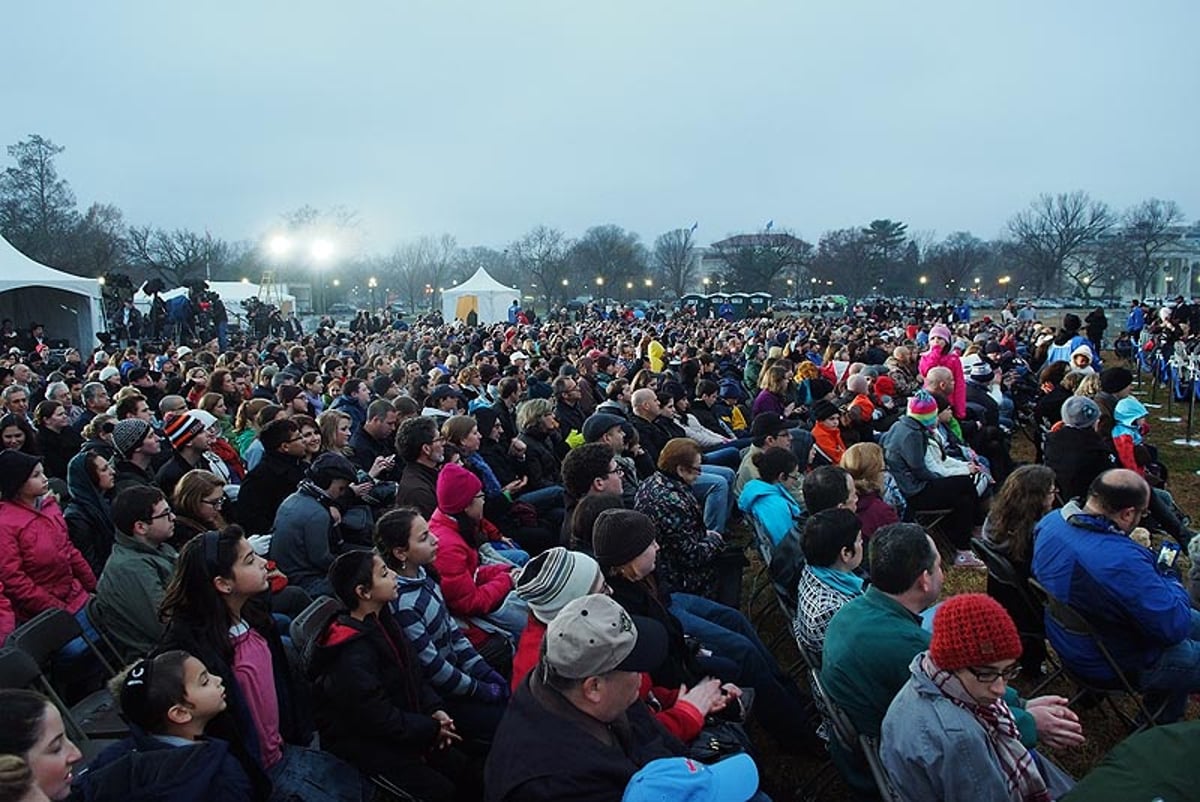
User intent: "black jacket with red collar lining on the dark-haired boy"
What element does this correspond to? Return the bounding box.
[308,609,442,774]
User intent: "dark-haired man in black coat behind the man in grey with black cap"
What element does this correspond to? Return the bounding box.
[238,418,306,534]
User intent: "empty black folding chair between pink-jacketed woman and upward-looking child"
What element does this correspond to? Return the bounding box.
[8,609,130,740]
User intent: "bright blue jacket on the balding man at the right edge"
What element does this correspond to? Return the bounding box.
[1033,503,1192,681]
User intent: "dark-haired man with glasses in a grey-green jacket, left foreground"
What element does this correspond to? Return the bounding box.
[95,485,179,662]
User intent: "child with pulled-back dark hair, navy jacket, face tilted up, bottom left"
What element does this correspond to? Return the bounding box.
[78,650,270,802]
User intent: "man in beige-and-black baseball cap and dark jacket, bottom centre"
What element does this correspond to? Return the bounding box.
[484,594,683,802]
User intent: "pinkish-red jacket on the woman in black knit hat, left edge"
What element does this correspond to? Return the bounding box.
[0,496,96,621]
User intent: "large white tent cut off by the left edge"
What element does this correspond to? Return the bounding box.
[0,237,107,352]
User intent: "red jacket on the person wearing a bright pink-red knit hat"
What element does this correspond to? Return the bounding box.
[430,509,512,617]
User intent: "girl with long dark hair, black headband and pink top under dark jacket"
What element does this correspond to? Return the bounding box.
[161,526,364,802]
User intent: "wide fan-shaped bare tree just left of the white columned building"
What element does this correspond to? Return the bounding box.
[1008,191,1112,293]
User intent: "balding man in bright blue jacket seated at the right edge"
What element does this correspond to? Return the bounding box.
[1033,468,1200,723]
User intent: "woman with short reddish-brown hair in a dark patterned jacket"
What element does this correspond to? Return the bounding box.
[634,437,742,608]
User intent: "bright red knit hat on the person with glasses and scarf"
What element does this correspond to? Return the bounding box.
[926,595,1021,671]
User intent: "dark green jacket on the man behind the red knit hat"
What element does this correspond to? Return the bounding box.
[821,587,1037,796]
